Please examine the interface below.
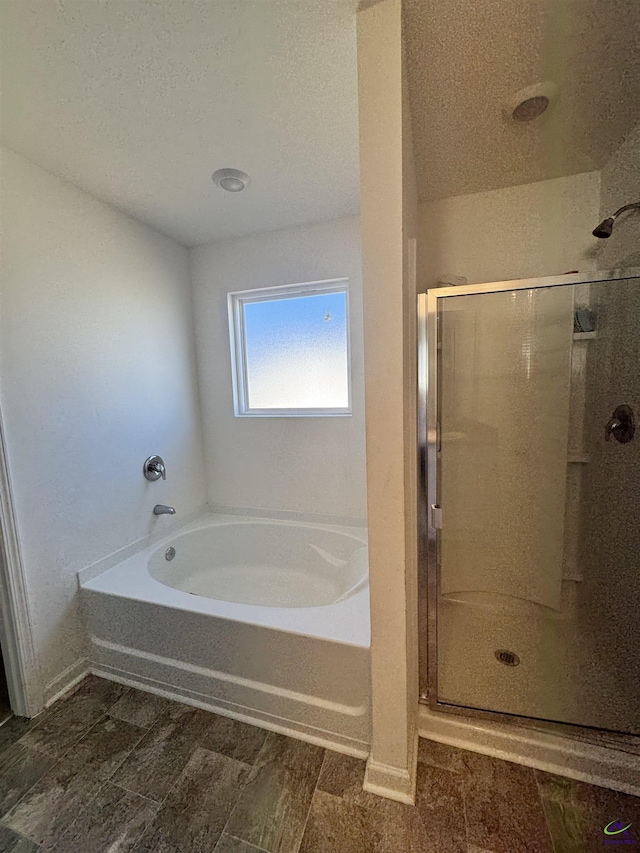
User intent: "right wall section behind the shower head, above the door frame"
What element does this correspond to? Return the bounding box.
[598,125,640,270]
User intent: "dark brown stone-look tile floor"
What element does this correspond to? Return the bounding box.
[0,676,640,853]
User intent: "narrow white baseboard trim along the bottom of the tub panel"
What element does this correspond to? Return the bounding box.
[90,663,369,758]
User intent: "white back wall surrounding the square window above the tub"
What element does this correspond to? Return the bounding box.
[192,217,366,519]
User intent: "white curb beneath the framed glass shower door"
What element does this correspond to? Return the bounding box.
[418,705,640,797]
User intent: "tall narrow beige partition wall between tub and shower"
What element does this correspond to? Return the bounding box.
[358,0,418,802]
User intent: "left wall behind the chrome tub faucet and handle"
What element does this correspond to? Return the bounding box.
[0,145,205,693]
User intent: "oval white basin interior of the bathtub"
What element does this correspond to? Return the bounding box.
[148,521,368,607]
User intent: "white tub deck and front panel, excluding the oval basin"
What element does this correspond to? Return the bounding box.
[80,515,370,757]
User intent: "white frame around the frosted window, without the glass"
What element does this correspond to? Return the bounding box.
[227,278,351,418]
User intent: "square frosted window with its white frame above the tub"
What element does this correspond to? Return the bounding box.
[228,278,351,417]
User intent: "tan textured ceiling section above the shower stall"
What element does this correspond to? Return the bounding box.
[404,0,640,201]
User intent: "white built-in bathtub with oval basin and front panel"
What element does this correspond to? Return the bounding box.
[80,515,370,756]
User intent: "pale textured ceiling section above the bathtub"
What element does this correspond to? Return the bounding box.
[0,0,359,245]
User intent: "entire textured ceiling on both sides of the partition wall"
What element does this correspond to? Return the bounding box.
[0,0,640,238]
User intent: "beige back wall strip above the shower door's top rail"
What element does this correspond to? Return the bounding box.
[418,172,601,289]
